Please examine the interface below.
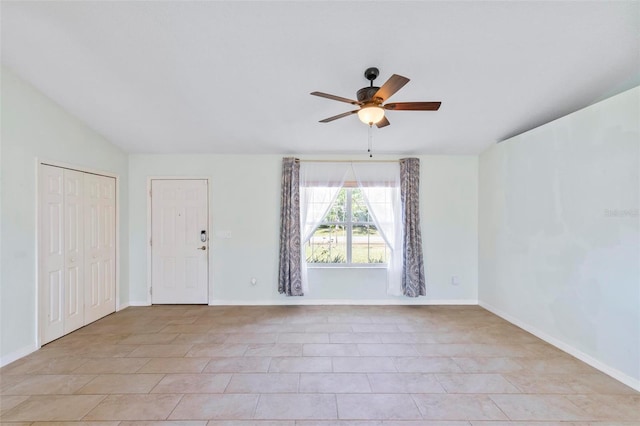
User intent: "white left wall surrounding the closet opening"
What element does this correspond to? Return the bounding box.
[0,67,129,365]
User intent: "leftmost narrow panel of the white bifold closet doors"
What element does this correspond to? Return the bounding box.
[39,166,65,344]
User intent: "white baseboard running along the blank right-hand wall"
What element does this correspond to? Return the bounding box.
[479,301,640,391]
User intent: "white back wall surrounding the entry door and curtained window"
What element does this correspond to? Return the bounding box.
[129,155,478,304]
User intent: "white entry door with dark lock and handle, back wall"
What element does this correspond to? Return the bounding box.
[151,179,209,304]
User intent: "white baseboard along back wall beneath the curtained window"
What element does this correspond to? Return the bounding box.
[209,297,478,306]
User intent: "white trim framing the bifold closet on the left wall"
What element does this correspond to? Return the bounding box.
[34,157,121,349]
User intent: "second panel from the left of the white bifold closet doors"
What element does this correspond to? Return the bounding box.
[64,170,85,334]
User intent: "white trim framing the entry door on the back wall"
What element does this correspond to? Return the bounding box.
[145,176,213,306]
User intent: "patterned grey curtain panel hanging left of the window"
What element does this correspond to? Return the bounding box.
[278,157,304,296]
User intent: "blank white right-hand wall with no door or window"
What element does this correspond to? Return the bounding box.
[479,87,640,389]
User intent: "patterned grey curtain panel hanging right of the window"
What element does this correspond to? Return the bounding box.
[400,158,427,297]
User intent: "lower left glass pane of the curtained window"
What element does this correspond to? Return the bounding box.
[305,225,347,263]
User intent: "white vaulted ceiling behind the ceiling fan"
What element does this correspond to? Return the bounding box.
[1,0,640,154]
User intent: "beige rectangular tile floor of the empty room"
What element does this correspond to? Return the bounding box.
[0,306,640,426]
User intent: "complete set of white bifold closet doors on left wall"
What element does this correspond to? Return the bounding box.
[38,164,116,344]
